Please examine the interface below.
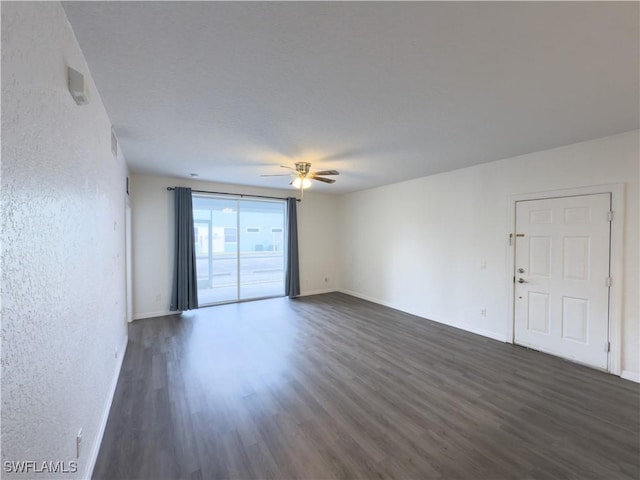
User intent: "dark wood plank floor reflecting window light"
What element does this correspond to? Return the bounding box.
[94,293,640,480]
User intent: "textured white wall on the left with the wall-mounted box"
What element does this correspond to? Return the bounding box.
[1,2,126,478]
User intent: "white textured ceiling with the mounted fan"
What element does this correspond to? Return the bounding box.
[64,2,640,193]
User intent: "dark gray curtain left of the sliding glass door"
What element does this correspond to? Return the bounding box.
[171,187,198,311]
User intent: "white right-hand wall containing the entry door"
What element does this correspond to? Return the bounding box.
[339,131,640,378]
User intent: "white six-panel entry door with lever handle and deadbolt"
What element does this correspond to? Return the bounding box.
[514,194,611,369]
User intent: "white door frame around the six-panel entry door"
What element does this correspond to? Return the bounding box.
[506,183,624,376]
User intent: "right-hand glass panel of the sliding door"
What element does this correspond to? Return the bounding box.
[239,200,285,300]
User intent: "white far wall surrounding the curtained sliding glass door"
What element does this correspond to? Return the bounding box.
[129,175,338,319]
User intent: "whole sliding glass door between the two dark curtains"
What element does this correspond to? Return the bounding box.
[193,195,285,306]
